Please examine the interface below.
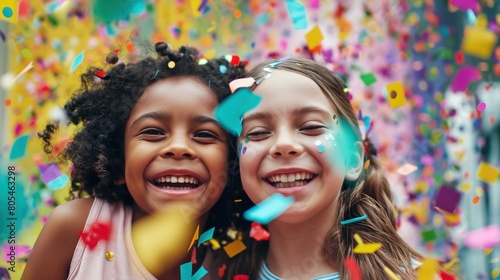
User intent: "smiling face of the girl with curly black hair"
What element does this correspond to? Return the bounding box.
[125,77,228,221]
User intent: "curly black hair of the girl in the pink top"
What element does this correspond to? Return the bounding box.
[38,42,245,232]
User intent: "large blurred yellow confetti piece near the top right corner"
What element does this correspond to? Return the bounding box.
[462,26,497,59]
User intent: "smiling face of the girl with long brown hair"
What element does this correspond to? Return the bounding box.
[239,70,346,223]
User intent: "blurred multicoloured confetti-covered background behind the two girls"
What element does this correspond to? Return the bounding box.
[0,0,500,279]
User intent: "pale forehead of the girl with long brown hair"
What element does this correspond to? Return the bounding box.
[250,70,335,113]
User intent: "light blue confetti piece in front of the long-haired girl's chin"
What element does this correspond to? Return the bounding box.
[243,193,293,225]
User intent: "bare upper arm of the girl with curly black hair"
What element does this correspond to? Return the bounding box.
[21,199,93,280]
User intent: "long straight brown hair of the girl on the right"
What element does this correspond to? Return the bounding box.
[225,59,422,279]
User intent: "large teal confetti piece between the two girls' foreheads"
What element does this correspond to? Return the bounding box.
[214,88,262,136]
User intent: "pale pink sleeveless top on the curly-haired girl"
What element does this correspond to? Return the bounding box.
[68,198,156,280]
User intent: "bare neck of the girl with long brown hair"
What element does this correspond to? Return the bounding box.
[266,207,337,279]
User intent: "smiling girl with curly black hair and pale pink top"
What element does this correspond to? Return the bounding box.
[23,42,244,279]
